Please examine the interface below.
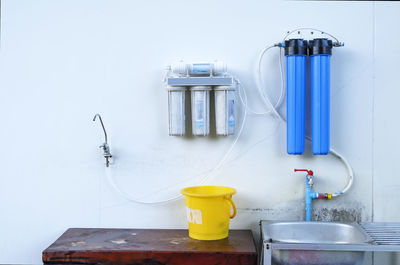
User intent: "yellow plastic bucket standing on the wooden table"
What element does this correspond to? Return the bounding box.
[181,186,236,240]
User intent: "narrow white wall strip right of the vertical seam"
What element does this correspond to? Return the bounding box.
[372,3,400,264]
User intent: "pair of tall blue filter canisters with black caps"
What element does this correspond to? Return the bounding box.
[277,35,343,155]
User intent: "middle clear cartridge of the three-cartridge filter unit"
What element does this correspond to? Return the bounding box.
[190,86,211,136]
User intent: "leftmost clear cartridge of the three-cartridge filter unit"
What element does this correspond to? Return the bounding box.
[167,86,186,136]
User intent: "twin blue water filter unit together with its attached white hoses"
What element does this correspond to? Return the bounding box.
[253,28,354,204]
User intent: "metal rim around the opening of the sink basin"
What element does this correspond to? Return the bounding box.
[260,220,374,245]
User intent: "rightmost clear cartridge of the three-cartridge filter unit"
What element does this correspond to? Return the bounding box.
[214,86,235,135]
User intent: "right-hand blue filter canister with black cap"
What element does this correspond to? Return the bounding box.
[309,39,332,155]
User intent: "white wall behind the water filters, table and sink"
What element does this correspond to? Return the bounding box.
[0,0,400,264]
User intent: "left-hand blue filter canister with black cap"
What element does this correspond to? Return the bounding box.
[284,39,308,155]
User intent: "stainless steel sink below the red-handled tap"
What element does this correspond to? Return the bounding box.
[262,222,371,265]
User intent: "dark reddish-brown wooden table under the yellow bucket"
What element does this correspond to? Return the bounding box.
[43,228,257,265]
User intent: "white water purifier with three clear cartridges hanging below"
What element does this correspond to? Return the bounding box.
[165,61,236,136]
